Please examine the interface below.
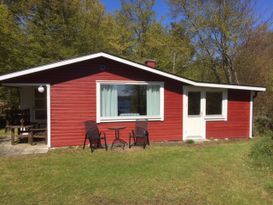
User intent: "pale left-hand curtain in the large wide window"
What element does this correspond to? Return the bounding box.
[101,85,118,117]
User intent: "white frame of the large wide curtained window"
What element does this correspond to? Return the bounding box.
[96,80,164,123]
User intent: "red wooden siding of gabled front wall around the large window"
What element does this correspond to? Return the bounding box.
[3,59,182,147]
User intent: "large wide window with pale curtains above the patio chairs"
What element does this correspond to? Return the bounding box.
[97,82,163,122]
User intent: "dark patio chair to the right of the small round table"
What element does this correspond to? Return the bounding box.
[129,120,150,149]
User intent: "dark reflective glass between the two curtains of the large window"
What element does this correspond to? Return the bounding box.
[117,85,147,116]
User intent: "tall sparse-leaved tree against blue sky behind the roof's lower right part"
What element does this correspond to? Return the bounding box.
[169,0,254,84]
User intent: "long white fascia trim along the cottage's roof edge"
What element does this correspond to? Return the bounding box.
[0,52,266,91]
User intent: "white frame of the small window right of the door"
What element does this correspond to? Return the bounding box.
[204,89,228,121]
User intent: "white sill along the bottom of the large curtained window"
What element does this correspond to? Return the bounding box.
[97,116,164,123]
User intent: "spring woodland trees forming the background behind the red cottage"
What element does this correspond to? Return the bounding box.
[0,0,273,128]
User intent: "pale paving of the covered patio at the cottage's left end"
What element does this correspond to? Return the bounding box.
[0,137,48,156]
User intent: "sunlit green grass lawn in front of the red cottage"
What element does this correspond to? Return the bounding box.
[0,141,273,205]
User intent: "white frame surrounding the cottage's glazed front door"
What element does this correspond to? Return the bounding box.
[182,86,206,141]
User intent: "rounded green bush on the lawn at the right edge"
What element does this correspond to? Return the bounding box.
[250,132,273,170]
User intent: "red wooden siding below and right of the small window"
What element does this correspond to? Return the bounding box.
[206,90,250,138]
